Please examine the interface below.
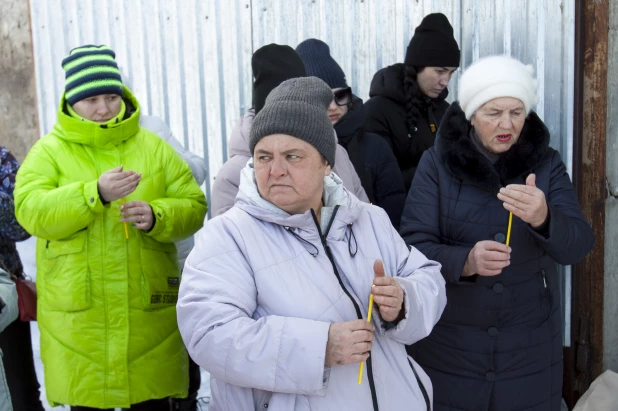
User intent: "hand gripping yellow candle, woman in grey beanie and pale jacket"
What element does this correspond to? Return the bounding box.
[324,320,374,366]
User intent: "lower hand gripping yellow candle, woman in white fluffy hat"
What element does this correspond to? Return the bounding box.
[461,240,511,277]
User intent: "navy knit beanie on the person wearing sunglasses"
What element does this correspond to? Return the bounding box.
[296,39,348,88]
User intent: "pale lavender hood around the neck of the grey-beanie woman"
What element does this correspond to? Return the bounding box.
[234,162,362,231]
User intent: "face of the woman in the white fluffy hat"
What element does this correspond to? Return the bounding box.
[470,97,526,154]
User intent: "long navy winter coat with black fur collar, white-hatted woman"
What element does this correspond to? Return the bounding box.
[401,103,594,411]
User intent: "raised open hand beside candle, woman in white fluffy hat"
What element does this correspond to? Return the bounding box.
[498,174,547,228]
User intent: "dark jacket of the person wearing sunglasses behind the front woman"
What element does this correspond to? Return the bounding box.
[335,96,406,230]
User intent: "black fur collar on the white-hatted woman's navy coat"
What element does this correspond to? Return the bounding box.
[435,102,549,193]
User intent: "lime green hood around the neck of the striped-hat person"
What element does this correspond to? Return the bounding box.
[54,86,140,147]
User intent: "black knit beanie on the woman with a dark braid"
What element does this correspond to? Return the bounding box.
[404,13,460,67]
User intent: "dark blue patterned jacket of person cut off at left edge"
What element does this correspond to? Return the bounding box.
[0,146,30,277]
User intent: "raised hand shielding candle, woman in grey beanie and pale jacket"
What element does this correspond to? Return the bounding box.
[371,260,403,322]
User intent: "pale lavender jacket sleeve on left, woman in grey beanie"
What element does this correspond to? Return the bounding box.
[177,216,330,395]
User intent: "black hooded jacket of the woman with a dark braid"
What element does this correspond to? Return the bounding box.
[365,63,449,192]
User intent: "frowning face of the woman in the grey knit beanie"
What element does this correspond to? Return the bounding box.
[253,134,331,214]
